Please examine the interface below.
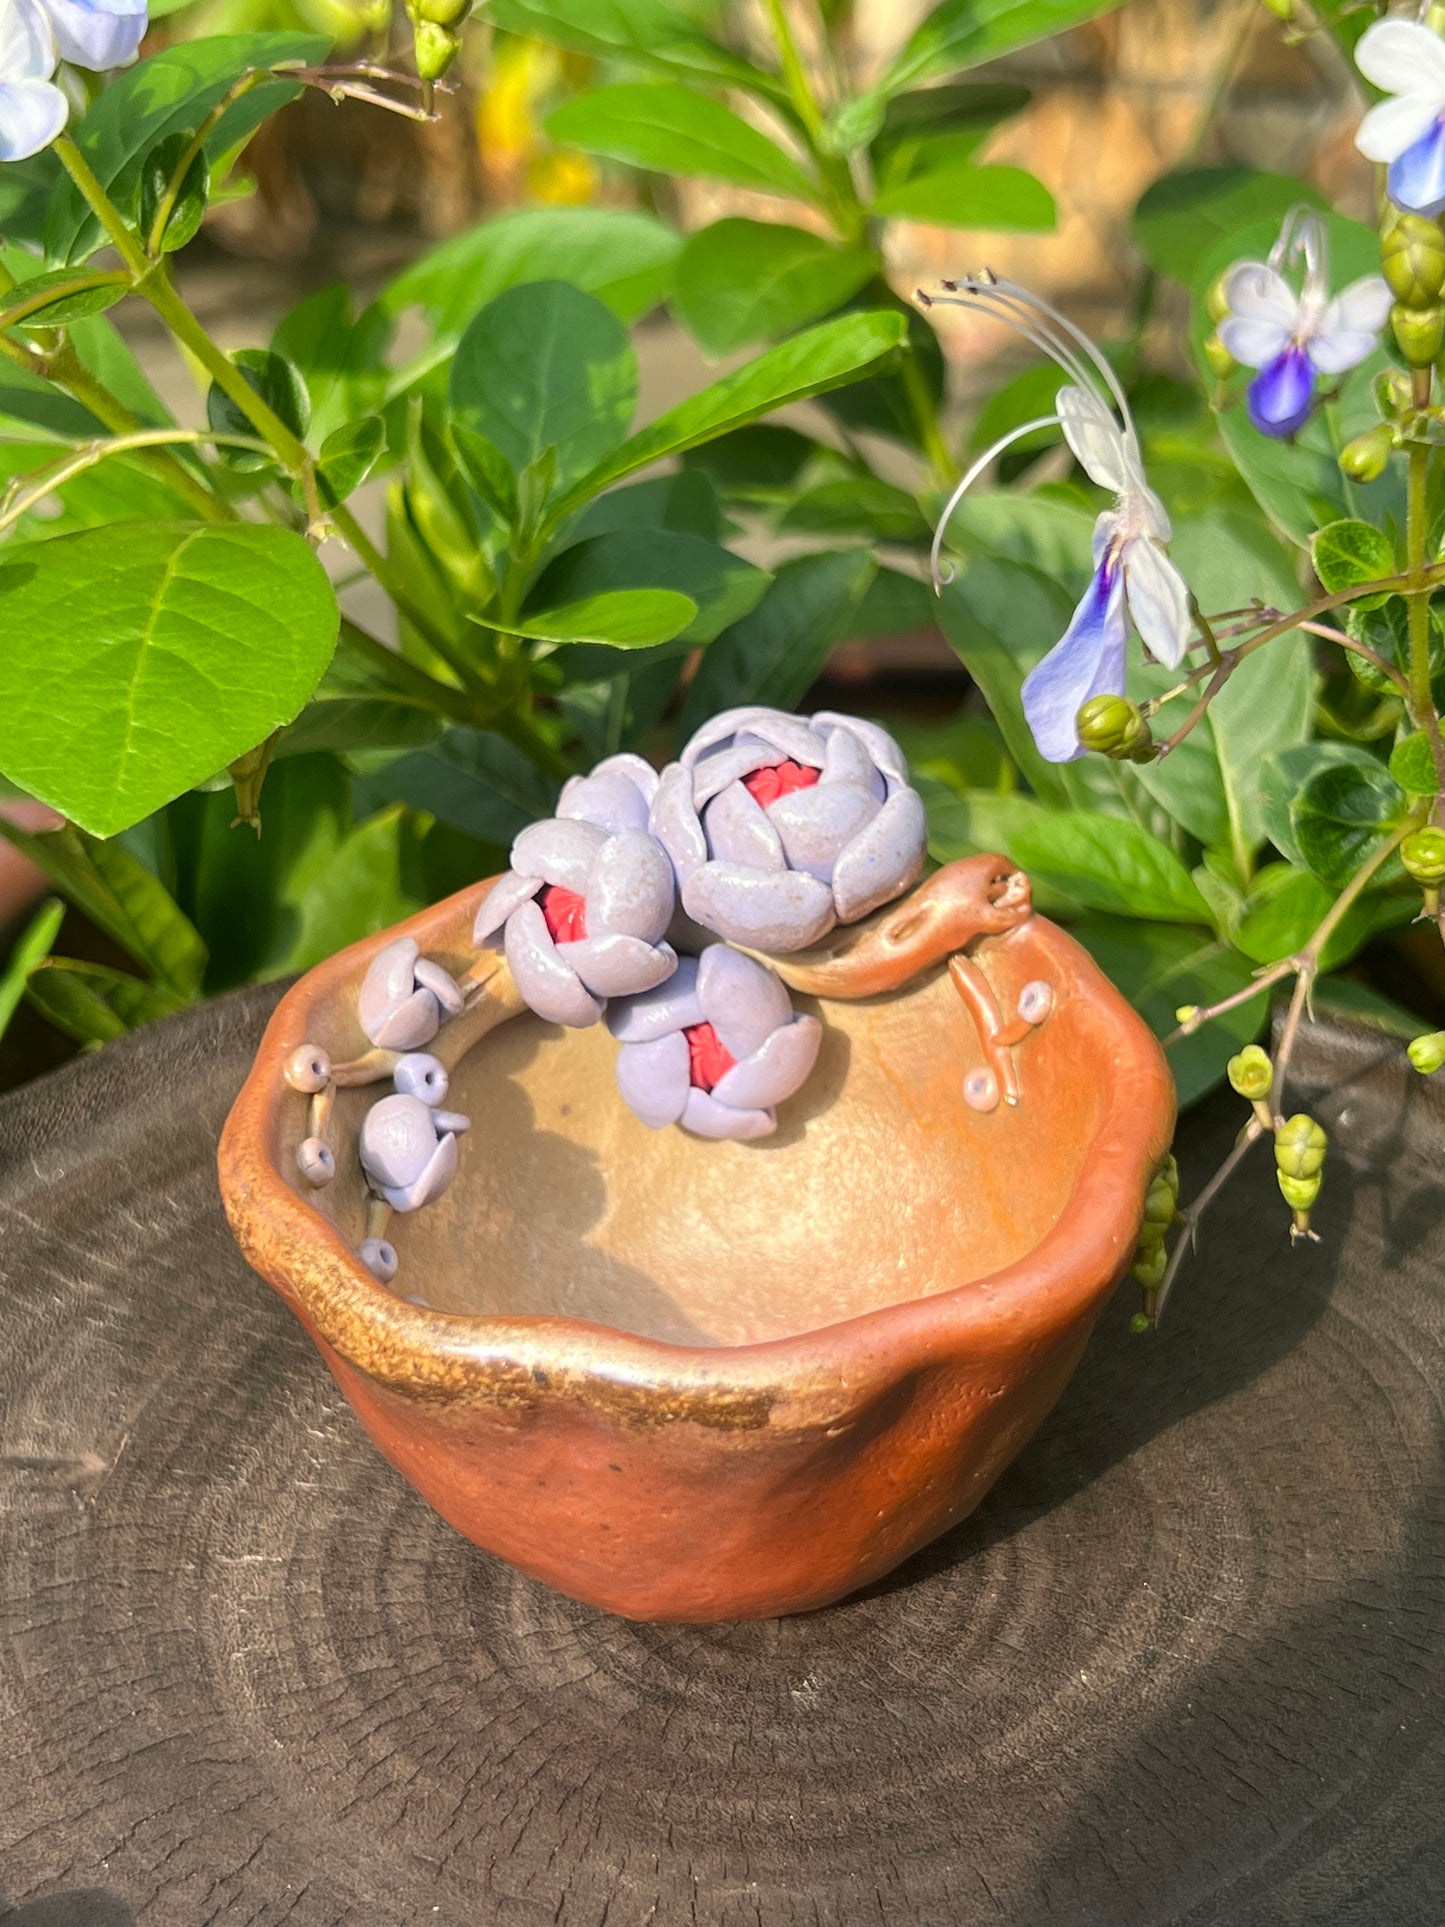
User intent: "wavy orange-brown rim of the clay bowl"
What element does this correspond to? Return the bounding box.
[218,877,1175,1430]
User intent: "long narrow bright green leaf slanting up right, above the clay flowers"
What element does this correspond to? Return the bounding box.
[557,312,907,515]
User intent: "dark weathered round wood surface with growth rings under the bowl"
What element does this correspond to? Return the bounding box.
[0,992,1445,1927]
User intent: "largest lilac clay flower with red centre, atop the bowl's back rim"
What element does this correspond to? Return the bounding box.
[651,707,927,950]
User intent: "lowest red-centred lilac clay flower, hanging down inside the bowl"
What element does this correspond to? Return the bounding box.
[607,944,823,1139]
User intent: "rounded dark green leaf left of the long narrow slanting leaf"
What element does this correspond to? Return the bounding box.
[451,281,638,501]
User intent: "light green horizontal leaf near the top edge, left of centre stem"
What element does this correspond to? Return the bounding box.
[547,81,817,200]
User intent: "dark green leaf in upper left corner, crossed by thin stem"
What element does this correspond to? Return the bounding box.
[44,33,331,262]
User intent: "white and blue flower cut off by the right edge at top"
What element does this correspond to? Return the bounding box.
[1354,19,1445,214]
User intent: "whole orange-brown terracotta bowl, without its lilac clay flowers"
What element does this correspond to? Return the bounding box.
[220,858,1173,1621]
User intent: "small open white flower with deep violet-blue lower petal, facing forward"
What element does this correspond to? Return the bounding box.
[1220,207,1394,439]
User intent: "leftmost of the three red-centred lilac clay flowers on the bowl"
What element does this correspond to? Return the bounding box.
[474,755,678,1029]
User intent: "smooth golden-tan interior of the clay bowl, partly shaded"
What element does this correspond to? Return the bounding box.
[333,944,1108,1345]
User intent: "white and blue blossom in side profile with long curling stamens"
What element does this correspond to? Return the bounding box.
[919,274,1191,763]
